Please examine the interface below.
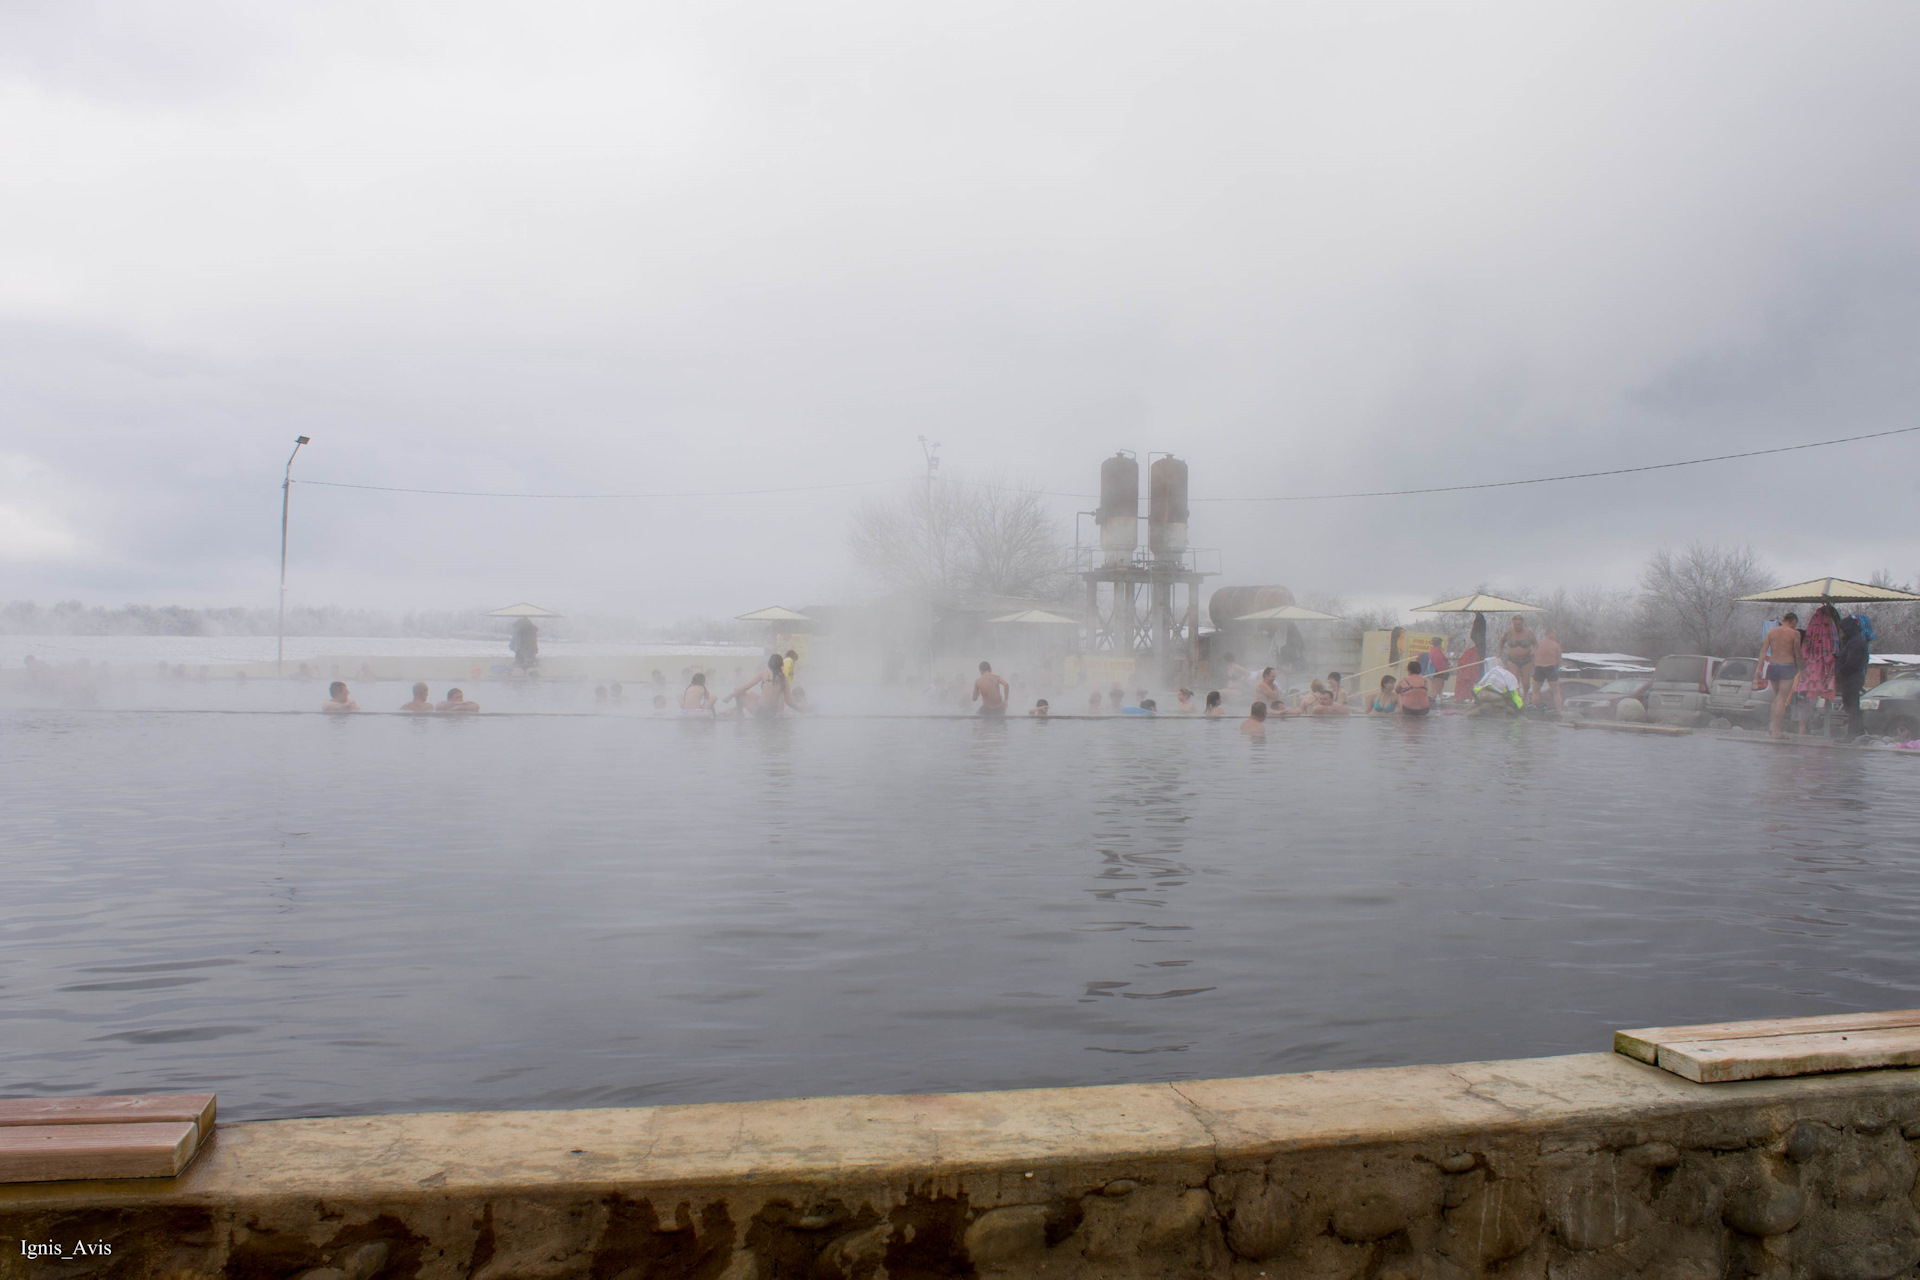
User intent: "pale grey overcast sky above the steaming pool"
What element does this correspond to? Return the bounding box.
[0,0,1920,622]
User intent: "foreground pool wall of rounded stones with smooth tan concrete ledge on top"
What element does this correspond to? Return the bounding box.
[0,1054,1920,1280]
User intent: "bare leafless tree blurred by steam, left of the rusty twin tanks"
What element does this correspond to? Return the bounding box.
[847,474,1068,599]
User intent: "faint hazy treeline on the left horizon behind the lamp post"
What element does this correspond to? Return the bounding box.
[0,601,758,645]
